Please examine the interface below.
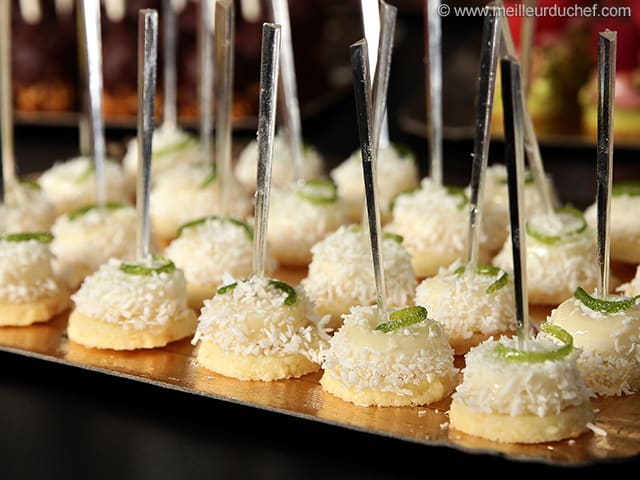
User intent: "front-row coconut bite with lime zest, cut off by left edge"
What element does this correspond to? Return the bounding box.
[0,232,70,326]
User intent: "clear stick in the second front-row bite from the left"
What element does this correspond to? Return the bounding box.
[136,9,158,261]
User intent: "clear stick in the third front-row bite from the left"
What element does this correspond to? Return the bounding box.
[253,23,281,277]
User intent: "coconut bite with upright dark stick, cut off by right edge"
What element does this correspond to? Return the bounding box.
[547,31,640,396]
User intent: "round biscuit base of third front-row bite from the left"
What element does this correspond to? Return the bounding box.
[197,341,320,382]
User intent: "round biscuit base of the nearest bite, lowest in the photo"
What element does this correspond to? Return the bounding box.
[449,400,593,443]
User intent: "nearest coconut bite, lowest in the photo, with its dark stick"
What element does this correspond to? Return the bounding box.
[449,55,594,443]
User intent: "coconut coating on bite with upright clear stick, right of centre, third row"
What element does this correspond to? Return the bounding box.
[385,178,469,276]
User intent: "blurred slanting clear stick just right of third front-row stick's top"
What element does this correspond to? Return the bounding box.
[271,0,304,181]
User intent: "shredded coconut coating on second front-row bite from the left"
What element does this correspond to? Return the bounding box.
[71,259,189,330]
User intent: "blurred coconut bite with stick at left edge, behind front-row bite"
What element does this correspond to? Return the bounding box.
[0,2,55,232]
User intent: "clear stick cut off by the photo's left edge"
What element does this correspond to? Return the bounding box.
[0,1,16,203]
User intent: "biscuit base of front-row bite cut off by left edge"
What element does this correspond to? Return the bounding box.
[0,291,70,327]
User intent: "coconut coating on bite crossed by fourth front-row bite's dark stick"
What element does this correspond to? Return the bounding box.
[301,225,418,313]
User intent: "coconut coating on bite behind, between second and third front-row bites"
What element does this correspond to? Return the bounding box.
[164,219,276,291]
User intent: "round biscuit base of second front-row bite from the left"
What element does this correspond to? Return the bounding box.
[67,310,197,350]
